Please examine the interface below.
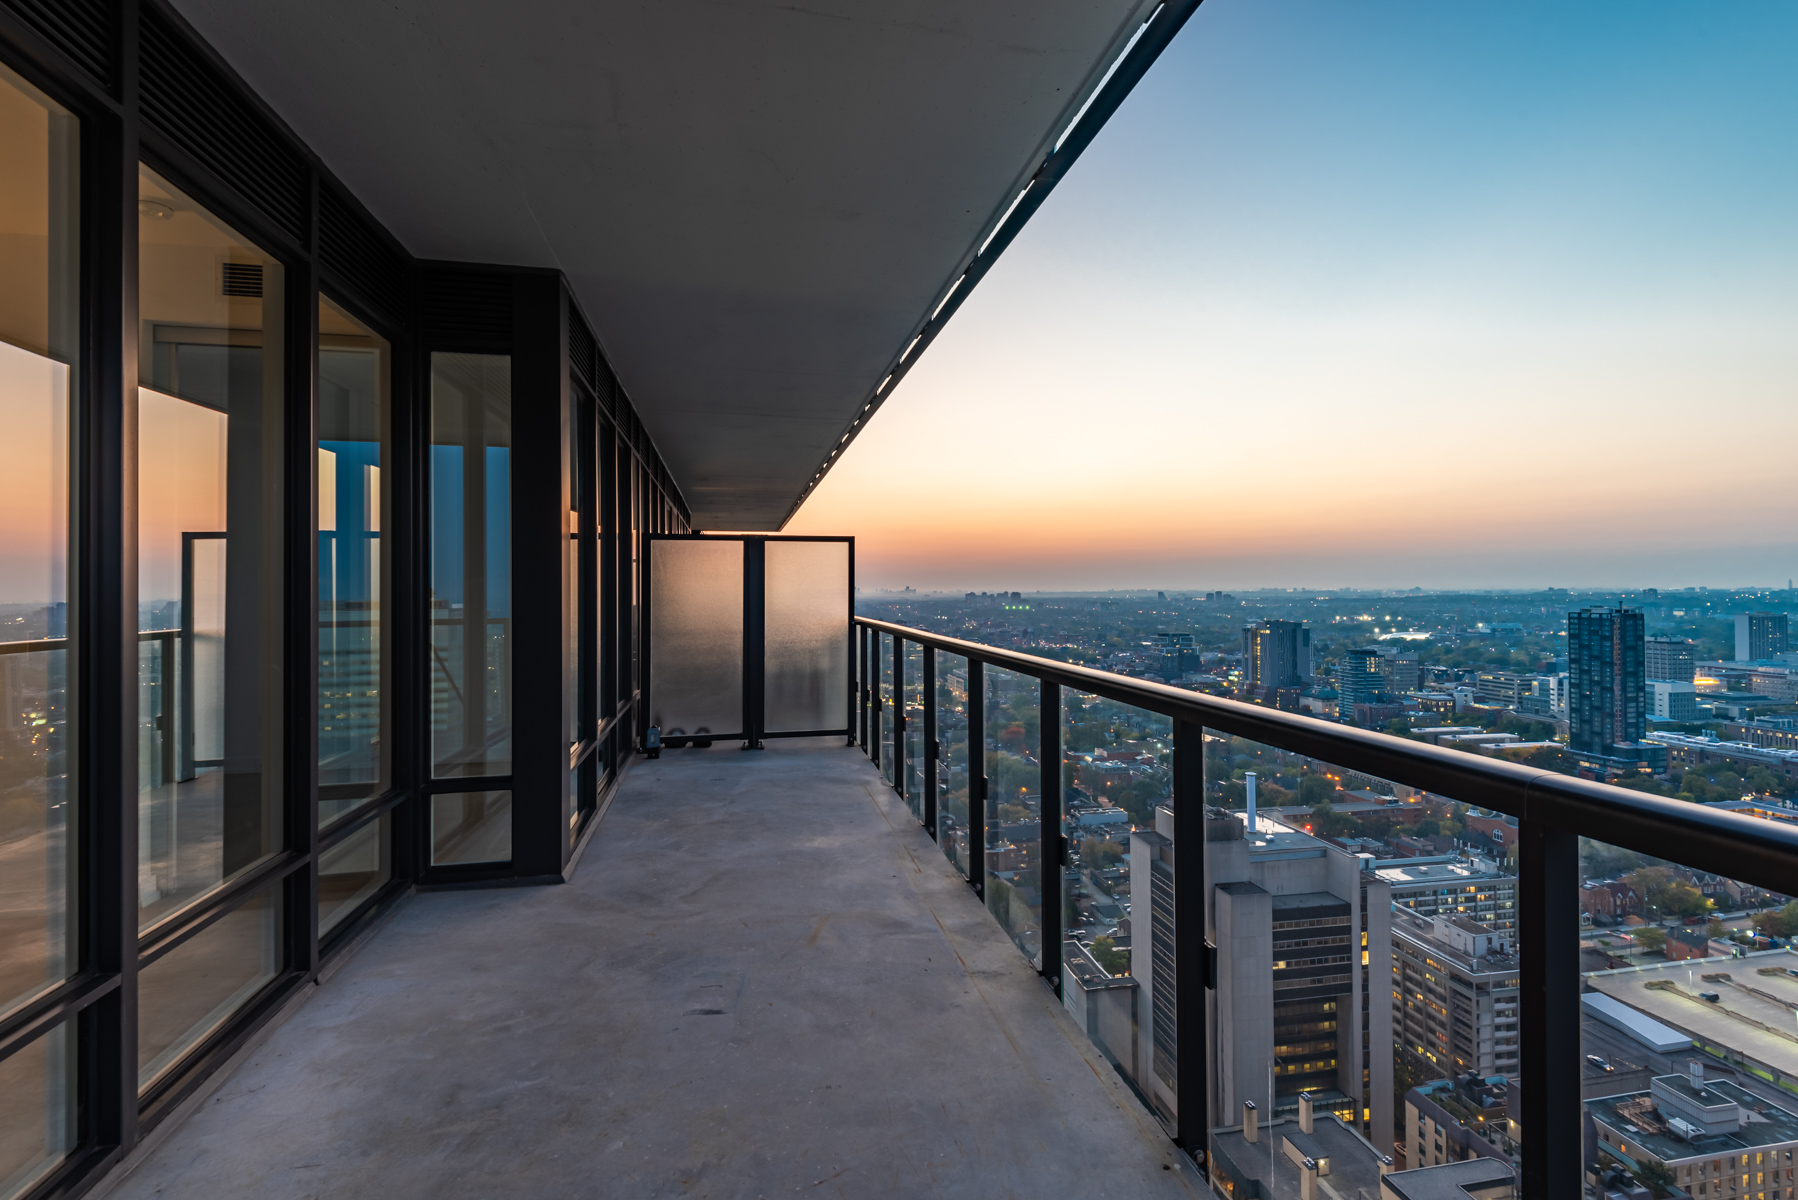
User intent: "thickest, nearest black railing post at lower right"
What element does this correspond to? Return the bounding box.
[1518,819,1584,1200]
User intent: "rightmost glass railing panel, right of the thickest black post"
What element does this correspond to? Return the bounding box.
[1568,831,1798,1200]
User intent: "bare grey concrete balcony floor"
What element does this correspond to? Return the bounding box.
[98,738,1206,1200]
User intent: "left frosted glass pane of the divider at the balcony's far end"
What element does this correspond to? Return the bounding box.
[649,538,743,739]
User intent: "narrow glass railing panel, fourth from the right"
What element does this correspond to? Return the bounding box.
[982,667,1054,964]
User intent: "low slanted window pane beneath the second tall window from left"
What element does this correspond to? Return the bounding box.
[137,882,282,1090]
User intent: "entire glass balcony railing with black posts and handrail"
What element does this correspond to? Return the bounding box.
[852,617,1798,1200]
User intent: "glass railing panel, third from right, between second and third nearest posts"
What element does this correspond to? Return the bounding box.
[1061,691,1174,1093]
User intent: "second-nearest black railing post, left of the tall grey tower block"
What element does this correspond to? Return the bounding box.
[1174,721,1212,1158]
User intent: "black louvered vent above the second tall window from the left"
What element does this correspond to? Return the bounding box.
[140,5,307,245]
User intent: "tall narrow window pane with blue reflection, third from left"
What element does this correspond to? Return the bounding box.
[318,299,392,824]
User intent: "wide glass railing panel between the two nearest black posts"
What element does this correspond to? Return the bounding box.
[1193,730,1521,1198]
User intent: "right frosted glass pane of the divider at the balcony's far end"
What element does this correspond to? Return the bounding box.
[764,542,849,732]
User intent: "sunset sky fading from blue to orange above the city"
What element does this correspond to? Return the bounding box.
[788,0,1798,590]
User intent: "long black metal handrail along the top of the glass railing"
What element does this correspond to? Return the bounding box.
[856,617,1798,894]
